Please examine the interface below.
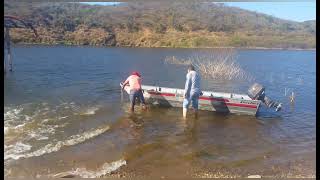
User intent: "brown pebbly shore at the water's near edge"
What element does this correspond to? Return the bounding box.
[103,160,316,178]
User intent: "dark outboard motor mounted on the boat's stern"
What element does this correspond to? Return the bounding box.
[248,83,281,111]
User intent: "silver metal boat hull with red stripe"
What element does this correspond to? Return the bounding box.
[121,86,261,116]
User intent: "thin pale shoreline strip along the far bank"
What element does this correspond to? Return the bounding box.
[14,43,316,51]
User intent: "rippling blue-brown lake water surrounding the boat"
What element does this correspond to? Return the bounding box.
[4,46,316,177]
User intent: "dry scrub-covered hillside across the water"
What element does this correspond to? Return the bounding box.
[4,1,316,49]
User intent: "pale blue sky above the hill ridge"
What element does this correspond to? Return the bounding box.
[82,0,316,22]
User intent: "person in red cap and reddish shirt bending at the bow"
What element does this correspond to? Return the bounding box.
[122,71,145,112]
